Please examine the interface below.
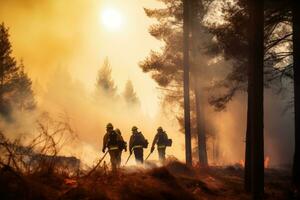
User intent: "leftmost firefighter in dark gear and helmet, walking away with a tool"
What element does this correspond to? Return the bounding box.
[102,123,124,171]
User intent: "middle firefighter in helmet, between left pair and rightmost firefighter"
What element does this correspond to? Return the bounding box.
[129,126,148,164]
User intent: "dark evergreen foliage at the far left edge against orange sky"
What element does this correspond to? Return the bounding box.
[0,23,35,119]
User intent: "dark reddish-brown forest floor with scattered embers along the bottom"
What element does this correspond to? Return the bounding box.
[0,161,296,200]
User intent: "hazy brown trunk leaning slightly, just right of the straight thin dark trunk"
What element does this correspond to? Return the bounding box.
[190,0,209,166]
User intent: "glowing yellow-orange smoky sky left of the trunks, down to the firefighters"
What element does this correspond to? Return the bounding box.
[0,0,188,162]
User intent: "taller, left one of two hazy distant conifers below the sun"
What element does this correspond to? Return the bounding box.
[96,58,117,98]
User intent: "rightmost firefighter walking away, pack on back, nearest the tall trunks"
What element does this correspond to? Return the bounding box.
[151,127,172,161]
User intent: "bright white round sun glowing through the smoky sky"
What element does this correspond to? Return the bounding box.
[100,8,123,31]
